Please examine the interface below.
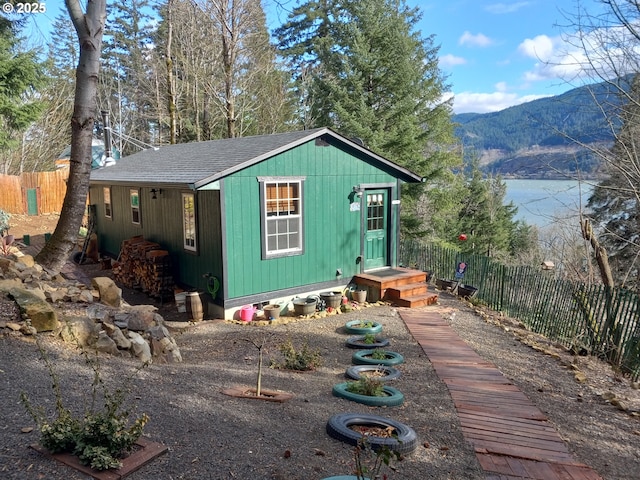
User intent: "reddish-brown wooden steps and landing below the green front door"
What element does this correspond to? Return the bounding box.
[353,267,438,308]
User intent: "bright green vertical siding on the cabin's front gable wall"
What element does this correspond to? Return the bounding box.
[223,142,397,298]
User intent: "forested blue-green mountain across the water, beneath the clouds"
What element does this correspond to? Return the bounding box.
[453,83,620,178]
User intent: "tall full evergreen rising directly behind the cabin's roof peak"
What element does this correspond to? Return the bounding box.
[276,0,460,234]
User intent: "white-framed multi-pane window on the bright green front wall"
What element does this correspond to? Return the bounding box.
[258,177,304,258]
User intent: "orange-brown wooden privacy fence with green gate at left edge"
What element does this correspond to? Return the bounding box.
[0,169,69,215]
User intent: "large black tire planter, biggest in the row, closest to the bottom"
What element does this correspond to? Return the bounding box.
[327,413,418,454]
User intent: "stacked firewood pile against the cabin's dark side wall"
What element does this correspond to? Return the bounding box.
[113,236,174,298]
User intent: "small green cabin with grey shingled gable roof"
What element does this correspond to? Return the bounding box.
[90,128,422,318]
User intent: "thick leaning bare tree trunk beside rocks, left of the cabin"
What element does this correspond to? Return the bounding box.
[36,0,107,273]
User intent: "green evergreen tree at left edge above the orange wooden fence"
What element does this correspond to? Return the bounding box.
[0,16,43,174]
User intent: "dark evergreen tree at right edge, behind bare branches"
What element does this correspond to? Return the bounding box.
[587,75,640,289]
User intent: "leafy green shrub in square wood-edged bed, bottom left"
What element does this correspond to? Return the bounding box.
[20,332,149,470]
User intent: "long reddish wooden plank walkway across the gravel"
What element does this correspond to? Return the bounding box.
[400,309,602,480]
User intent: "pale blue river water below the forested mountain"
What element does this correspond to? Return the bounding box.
[504,179,593,228]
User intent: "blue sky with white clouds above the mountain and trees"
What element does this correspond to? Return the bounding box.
[25,0,597,113]
